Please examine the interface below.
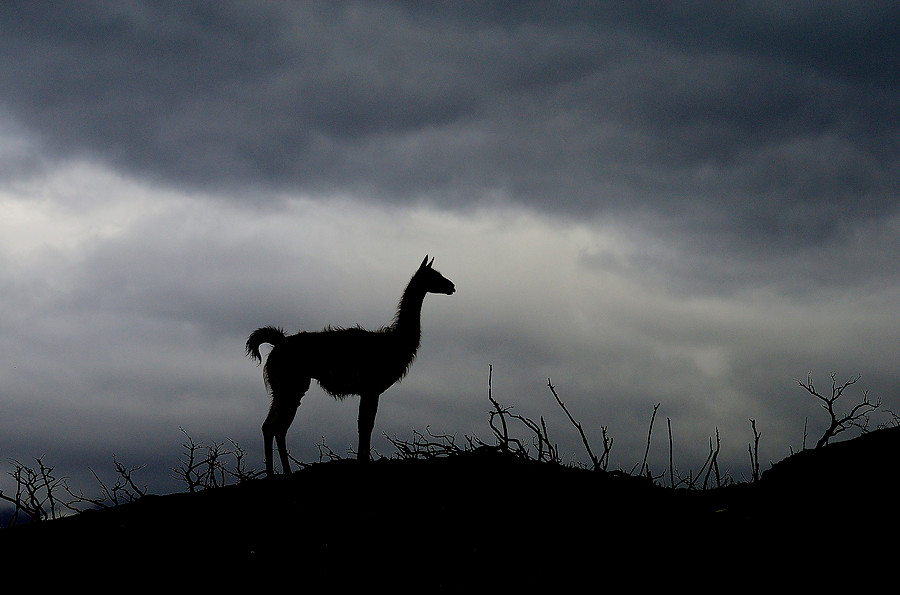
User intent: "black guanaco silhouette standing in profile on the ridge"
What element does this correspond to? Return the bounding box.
[246,256,456,477]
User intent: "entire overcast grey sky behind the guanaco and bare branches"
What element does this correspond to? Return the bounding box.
[0,0,900,500]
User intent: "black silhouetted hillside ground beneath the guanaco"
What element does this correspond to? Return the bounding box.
[0,428,900,592]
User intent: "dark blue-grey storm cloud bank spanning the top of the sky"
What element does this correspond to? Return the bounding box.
[0,2,900,257]
